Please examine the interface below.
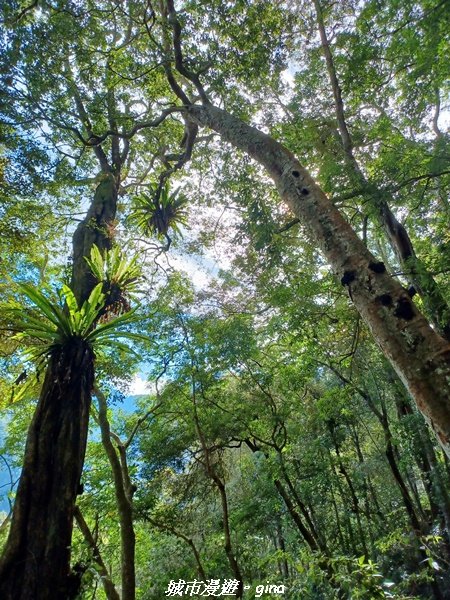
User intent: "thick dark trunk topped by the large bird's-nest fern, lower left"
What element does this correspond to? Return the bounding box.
[0,342,94,600]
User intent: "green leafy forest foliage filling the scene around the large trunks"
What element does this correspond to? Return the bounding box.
[0,0,450,600]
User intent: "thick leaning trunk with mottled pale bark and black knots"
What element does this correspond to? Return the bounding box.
[186,103,450,455]
